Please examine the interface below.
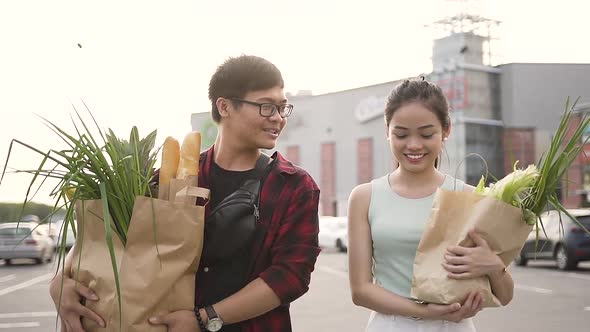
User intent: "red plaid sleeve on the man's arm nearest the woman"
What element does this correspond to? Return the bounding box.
[260,183,320,304]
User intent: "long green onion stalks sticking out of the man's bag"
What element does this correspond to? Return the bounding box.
[0,105,159,326]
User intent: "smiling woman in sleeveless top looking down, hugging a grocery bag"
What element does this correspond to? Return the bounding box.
[348,80,514,331]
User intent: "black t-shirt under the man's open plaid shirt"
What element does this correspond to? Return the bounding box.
[196,161,257,332]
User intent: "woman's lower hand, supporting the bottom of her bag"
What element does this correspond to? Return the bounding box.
[424,291,483,323]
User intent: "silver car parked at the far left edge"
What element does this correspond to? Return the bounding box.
[0,222,55,265]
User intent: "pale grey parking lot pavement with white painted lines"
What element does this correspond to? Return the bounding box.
[0,249,590,332]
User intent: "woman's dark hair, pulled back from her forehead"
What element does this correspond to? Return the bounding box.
[385,78,451,130]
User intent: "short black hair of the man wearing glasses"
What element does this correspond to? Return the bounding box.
[209,55,285,123]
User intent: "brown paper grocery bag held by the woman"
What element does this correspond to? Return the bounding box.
[411,189,533,307]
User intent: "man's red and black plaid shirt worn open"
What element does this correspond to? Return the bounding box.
[196,147,320,332]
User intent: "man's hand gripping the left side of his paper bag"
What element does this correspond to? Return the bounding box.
[49,272,105,332]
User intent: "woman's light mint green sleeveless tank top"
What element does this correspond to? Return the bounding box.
[369,175,464,298]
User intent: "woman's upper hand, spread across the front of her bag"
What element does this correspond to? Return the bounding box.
[442,230,505,280]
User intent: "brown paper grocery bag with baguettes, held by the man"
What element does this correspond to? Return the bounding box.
[72,186,209,332]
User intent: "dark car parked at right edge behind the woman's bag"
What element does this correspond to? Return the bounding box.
[515,209,590,270]
